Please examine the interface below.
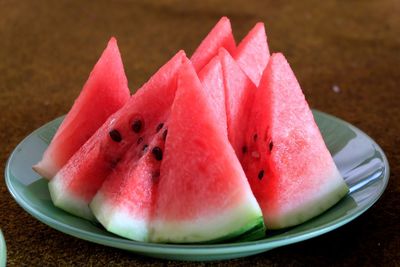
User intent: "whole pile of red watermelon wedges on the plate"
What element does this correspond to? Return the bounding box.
[33,17,348,243]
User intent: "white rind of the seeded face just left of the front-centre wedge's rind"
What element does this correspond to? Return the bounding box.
[90,193,149,242]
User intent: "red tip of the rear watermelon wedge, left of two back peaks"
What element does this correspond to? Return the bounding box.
[190,17,236,72]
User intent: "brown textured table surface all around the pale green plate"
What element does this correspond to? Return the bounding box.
[0,0,400,266]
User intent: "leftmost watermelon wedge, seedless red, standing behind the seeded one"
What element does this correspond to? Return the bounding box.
[33,38,130,179]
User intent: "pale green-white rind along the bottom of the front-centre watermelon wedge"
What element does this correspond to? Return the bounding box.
[150,197,264,243]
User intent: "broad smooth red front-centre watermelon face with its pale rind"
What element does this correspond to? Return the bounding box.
[150,60,264,243]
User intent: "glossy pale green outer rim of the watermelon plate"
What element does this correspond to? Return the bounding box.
[4,109,390,256]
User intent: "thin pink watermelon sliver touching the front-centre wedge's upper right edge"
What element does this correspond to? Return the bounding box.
[199,56,228,135]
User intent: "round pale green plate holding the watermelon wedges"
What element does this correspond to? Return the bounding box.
[5,111,389,260]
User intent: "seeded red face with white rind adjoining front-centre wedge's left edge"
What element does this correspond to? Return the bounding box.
[90,122,168,241]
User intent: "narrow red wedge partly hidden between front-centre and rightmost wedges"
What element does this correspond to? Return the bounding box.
[219,48,256,160]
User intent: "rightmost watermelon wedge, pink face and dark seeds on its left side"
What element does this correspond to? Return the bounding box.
[243,54,348,229]
